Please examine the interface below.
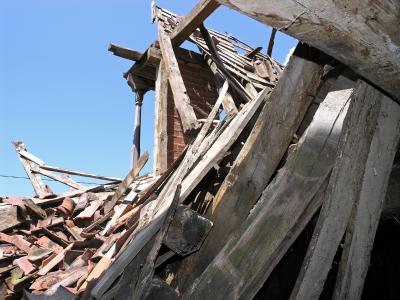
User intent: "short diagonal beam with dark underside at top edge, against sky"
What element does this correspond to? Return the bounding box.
[171,0,220,46]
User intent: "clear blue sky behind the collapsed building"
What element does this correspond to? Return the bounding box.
[0,0,296,196]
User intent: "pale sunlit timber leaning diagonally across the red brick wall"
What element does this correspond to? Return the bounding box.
[158,24,199,132]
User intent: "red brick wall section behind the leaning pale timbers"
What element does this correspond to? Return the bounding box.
[167,62,218,166]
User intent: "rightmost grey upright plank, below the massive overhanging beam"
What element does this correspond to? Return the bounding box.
[333,84,400,300]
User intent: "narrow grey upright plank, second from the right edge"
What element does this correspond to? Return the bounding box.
[291,81,396,299]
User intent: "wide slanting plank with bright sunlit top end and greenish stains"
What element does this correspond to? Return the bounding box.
[183,79,352,299]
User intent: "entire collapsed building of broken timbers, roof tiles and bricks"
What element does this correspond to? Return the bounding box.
[0,0,400,300]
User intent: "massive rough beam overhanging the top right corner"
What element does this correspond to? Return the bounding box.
[217,0,400,100]
